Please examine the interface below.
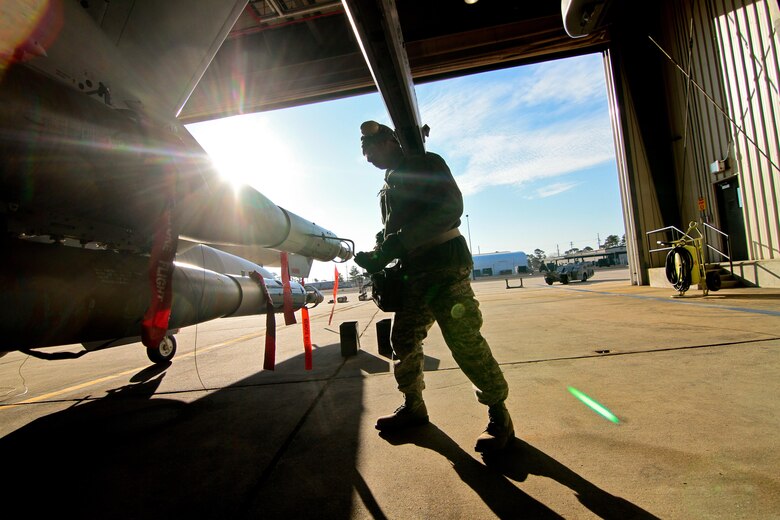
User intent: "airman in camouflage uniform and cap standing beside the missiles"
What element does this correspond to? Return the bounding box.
[355,121,514,453]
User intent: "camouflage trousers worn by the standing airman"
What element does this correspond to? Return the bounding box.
[391,267,509,406]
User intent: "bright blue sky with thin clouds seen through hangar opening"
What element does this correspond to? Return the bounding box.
[187,54,624,280]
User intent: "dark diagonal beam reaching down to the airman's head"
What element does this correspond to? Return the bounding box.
[342,0,425,155]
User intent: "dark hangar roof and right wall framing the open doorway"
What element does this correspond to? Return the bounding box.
[171,0,780,287]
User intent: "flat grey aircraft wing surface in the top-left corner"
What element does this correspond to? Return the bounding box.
[12,0,246,120]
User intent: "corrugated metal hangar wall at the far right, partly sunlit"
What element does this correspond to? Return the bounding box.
[657,0,780,260]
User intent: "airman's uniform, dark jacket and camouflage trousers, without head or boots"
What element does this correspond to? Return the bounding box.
[377,153,509,406]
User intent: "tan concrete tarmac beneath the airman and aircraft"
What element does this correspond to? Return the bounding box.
[0,269,780,519]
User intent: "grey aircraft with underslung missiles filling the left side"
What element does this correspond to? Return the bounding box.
[0,0,352,362]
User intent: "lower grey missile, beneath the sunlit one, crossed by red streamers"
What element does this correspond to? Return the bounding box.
[0,239,323,351]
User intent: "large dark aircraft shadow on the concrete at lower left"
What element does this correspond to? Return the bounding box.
[0,345,362,519]
